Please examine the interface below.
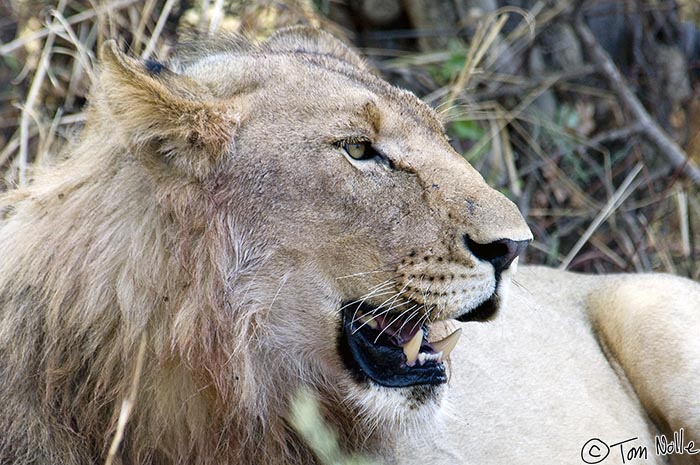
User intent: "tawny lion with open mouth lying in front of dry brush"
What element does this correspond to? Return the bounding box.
[0,27,700,465]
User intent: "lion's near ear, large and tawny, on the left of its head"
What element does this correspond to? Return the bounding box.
[100,40,239,178]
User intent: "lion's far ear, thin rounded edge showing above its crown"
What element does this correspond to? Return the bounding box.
[262,26,367,69]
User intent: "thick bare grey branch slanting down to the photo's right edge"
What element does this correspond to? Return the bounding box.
[574,15,700,184]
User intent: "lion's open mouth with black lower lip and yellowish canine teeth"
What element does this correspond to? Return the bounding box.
[339,304,462,387]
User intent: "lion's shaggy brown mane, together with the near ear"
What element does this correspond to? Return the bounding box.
[0,28,344,465]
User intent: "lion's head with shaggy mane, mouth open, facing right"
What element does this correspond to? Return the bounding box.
[0,28,531,463]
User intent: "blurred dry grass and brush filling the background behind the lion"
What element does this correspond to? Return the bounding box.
[0,0,700,279]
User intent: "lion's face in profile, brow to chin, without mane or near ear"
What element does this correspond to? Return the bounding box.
[100,30,531,434]
